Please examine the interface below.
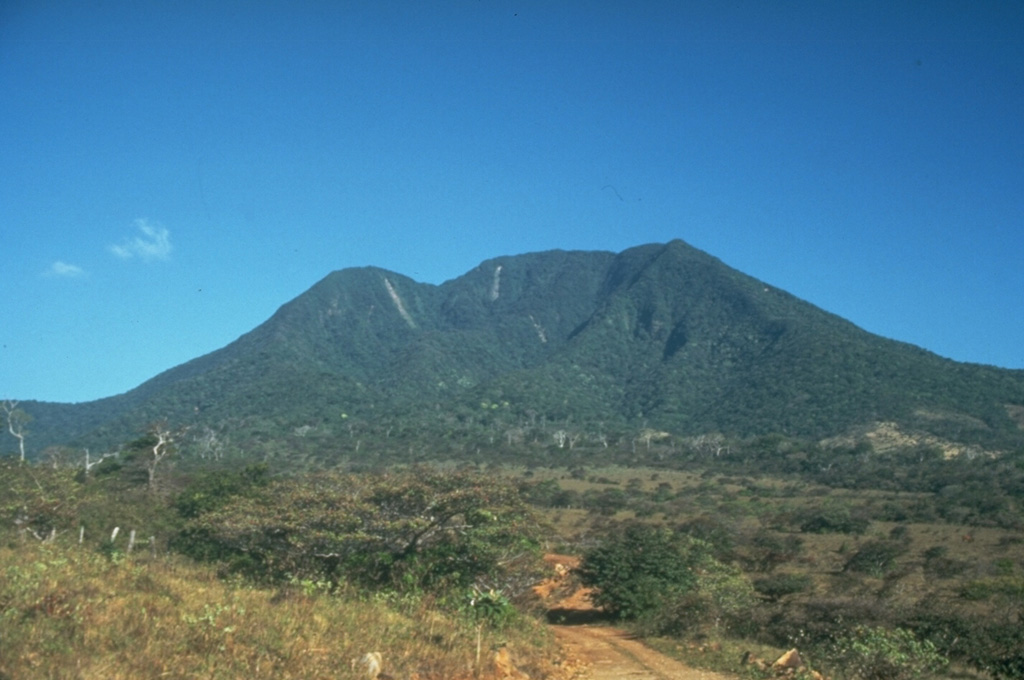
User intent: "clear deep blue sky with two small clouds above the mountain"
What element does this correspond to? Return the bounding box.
[0,0,1024,401]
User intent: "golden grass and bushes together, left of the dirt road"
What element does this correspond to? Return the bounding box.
[0,463,555,680]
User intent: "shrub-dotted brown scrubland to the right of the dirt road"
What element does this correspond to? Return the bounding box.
[524,463,1024,678]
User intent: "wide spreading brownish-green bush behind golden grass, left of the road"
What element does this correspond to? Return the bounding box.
[181,468,538,590]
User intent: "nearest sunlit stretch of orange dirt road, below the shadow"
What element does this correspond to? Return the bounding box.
[551,626,735,680]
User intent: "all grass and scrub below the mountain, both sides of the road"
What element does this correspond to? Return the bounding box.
[0,421,1024,679]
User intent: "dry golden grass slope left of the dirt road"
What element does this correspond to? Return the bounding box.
[0,543,551,680]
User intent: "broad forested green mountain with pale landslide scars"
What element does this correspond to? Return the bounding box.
[16,241,1024,456]
